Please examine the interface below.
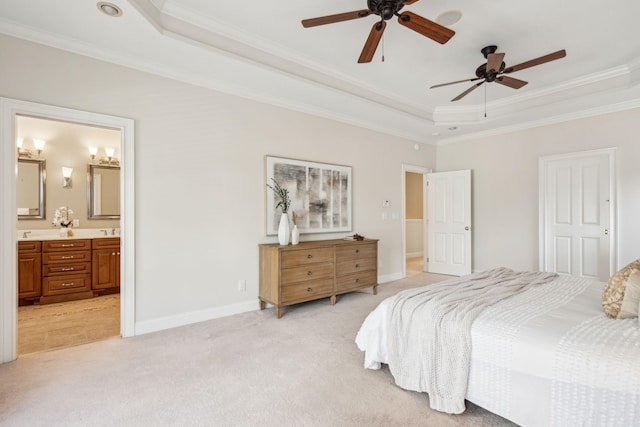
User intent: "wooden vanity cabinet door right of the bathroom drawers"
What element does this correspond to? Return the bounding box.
[91,237,120,291]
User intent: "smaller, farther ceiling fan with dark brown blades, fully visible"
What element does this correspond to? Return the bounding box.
[430,45,567,102]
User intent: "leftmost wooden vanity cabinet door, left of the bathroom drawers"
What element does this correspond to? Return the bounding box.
[16,241,42,305]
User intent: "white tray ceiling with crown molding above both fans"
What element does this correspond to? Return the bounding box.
[0,0,640,143]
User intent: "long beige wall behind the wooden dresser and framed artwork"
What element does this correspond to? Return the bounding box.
[0,36,435,323]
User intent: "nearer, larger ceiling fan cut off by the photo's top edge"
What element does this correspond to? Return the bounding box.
[302,0,455,63]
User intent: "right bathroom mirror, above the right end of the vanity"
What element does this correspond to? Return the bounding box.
[87,165,120,219]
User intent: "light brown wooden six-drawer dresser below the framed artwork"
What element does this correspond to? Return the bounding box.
[259,239,378,318]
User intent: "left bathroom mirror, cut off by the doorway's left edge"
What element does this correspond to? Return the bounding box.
[16,159,46,220]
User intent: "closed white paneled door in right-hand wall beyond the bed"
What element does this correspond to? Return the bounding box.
[540,150,615,281]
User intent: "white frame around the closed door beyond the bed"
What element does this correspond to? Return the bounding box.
[538,148,618,274]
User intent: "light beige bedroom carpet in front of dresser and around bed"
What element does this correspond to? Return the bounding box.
[0,274,512,427]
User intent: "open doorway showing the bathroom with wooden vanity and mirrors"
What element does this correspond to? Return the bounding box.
[15,115,122,357]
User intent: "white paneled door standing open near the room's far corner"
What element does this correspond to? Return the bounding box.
[427,170,471,276]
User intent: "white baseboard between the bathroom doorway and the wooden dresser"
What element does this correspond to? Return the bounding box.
[135,298,259,335]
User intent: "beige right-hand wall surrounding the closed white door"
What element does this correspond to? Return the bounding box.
[437,109,640,271]
